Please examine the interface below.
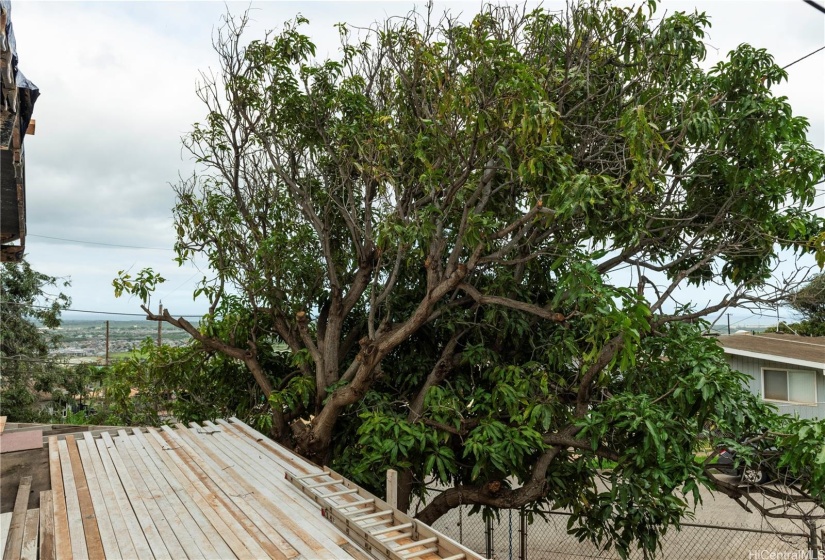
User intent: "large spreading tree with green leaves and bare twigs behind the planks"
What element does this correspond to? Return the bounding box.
[114,1,825,551]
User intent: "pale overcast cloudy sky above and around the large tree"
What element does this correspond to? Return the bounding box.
[12,0,825,321]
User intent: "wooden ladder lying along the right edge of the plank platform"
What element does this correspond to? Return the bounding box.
[286,468,484,560]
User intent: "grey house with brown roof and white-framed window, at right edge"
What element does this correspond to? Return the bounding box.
[718,333,825,418]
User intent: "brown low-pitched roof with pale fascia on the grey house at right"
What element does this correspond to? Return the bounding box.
[717,333,825,370]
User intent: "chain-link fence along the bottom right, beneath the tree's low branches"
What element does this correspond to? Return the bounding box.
[433,506,825,560]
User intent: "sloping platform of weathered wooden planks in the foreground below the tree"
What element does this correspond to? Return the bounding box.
[0,419,482,560]
